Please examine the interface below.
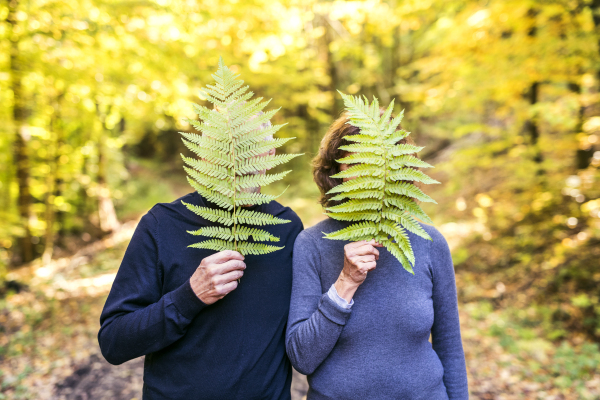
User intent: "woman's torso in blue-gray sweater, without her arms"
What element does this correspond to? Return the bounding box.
[302,219,447,400]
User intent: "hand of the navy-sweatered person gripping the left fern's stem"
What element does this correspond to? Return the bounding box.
[190,250,246,304]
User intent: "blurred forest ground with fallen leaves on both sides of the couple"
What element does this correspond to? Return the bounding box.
[0,223,600,400]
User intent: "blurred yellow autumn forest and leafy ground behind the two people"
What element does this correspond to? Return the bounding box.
[0,0,600,399]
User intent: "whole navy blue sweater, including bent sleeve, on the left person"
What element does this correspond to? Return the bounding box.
[98,192,302,400]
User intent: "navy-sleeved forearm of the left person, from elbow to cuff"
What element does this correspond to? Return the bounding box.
[98,282,205,364]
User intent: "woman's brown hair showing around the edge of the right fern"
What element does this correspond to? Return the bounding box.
[312,109,416,207]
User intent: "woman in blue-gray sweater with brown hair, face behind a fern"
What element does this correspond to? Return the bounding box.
[286,115,469,400]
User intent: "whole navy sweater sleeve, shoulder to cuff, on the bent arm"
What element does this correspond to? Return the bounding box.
[98,213,205,365]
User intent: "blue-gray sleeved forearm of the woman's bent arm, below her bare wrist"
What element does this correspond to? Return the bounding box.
[286,293,350,375]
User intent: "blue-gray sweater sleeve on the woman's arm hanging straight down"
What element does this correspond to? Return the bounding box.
[431,231,469,400]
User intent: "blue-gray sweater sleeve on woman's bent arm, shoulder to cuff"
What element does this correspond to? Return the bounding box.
[286,231,351,375]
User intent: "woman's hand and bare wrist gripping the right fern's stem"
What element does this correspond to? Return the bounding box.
[335,240,383,302]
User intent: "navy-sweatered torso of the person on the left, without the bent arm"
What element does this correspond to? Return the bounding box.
[144,193,301,399]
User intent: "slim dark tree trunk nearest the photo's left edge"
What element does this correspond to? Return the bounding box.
[6,0,33,262]
